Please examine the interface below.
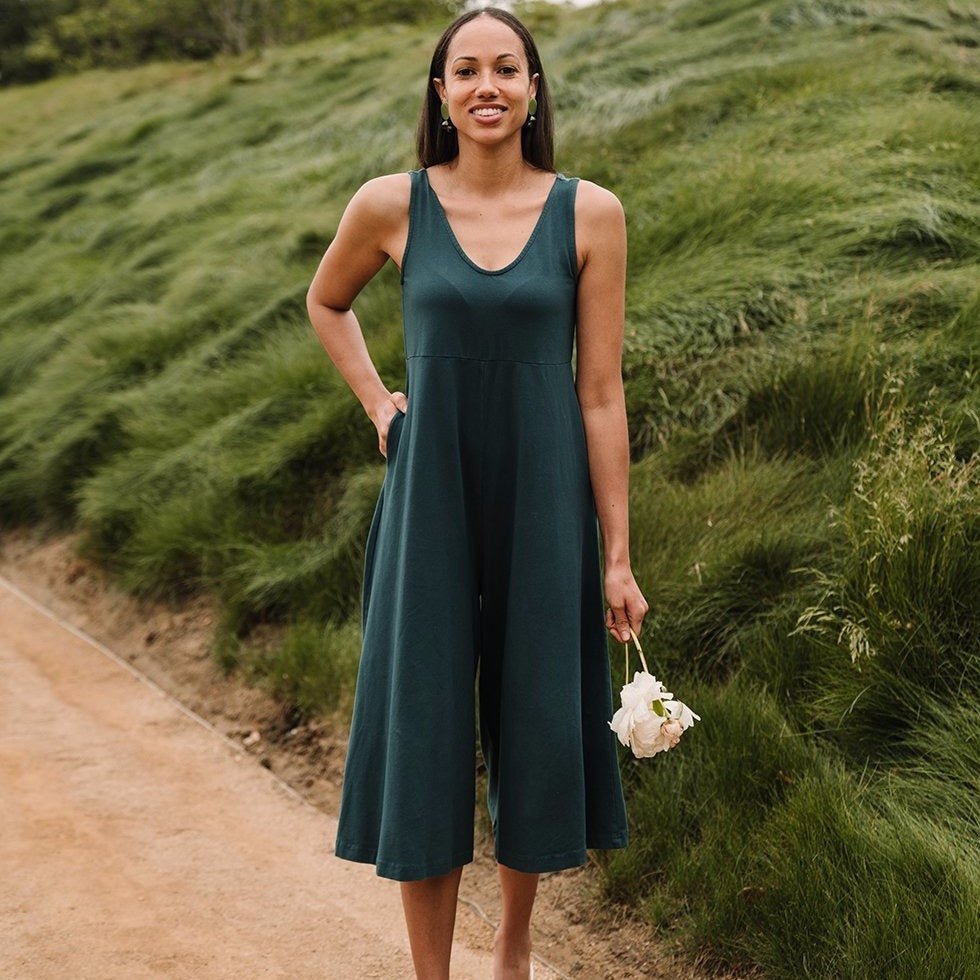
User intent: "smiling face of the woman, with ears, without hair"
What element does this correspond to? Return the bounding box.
[432,16,538,143]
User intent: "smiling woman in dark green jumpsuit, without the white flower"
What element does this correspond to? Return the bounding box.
[308,8,649,980]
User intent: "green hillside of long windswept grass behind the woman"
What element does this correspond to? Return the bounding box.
[0,0,980,980]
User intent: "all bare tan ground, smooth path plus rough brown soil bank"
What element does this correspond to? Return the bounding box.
[0,529,748,980]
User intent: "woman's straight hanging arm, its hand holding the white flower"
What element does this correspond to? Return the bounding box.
[575,180,650,642]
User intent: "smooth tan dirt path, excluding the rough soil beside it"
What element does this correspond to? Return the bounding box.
[0,582,512,980]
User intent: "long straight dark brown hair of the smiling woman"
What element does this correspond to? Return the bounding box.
[416,7,555,171]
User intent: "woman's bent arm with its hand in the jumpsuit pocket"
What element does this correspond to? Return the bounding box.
[306,174,410,455]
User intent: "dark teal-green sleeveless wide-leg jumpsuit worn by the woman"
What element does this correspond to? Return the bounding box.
[334,170,628,881]
